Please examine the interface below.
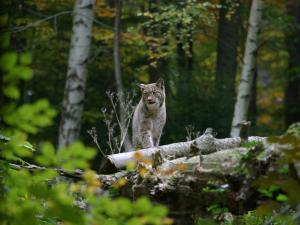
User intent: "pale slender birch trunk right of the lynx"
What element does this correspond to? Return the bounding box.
[230,0,263,137]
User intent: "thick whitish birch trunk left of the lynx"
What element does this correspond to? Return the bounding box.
[58,0,95,149]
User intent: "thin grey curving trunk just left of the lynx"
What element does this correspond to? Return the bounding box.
[114,0,131,152]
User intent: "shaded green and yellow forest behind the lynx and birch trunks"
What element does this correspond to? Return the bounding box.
[3,0,300,162]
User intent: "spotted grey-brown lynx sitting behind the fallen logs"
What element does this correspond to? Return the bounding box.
[132,79,166,149]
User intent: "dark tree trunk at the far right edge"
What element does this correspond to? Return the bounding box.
[285,0,300,127]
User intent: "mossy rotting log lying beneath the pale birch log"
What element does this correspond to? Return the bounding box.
[4,137,277,224]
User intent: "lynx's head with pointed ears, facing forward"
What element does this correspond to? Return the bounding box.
[139,78,165,110]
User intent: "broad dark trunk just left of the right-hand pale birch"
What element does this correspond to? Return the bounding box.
[216,0,239,136]
